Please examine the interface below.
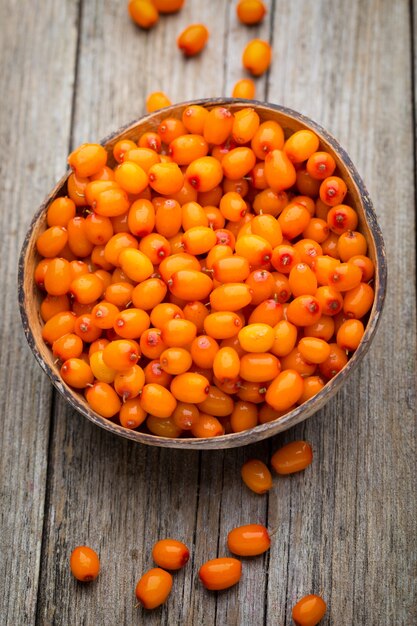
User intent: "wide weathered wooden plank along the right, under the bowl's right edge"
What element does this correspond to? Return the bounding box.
[267,1,416,626]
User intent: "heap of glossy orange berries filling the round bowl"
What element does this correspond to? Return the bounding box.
[35,105,374,437]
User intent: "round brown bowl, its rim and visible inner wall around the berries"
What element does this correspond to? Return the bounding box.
[18,98,387,450]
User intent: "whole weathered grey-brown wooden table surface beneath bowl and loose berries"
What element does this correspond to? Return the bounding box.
[0,0,417,626]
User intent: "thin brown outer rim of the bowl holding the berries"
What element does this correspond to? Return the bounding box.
[17,98,387,450]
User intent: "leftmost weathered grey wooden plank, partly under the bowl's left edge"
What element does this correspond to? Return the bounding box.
[0,0,78,624]
